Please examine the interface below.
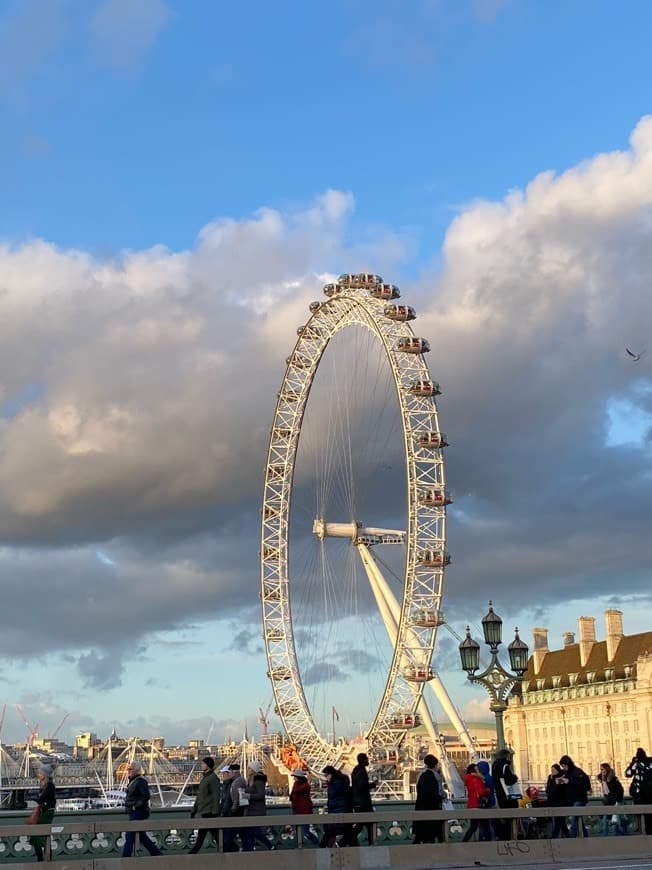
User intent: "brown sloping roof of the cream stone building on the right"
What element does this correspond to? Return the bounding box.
[523,631,652,691]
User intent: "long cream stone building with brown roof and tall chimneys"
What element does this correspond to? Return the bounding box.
[504,609,652,782]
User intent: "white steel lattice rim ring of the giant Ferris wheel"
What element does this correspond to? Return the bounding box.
[261,274,449,771]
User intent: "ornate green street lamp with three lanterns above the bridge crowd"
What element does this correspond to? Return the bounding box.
[459,601,528,749]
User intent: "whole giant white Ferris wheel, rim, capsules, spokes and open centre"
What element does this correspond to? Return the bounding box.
[261,273,450,771]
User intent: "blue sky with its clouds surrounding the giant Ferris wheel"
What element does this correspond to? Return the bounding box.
[0,0,652,739]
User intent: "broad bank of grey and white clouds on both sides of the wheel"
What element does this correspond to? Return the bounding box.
[0,118,652,685]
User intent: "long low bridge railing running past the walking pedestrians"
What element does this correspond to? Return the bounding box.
[0,804,652,862]
